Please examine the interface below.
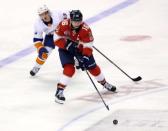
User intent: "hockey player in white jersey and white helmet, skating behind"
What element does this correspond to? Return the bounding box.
[30,5,69,76]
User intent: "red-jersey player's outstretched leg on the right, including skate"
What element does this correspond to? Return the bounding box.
[88,56,116,92]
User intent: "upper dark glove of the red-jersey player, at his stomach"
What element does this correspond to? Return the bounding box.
[65,39,78,55]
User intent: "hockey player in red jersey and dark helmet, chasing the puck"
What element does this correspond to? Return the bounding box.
[54,10,116,103]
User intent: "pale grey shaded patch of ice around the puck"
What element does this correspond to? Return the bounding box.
[86,110,168,131]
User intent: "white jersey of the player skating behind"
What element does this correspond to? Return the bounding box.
[33,11,69,43]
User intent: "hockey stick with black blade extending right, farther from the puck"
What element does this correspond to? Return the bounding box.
[93,46,142,82]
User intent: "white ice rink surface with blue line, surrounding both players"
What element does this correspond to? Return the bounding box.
[0,0,168,131]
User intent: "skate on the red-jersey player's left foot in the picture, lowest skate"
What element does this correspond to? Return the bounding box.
[55,88,65,104]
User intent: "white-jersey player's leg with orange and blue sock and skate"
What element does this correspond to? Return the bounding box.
[30,35,55,76]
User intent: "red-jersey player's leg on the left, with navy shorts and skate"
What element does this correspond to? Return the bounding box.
[55,49,75,104]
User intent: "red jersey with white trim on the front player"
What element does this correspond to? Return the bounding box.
[54,19,94,56]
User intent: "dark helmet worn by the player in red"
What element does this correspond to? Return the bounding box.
[70,10,83,21]
